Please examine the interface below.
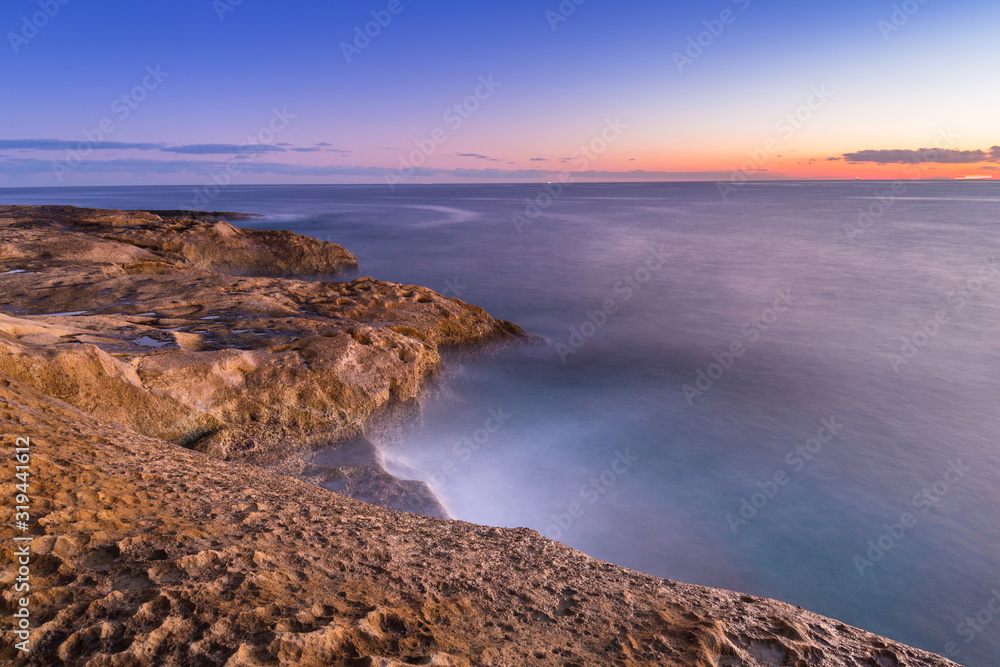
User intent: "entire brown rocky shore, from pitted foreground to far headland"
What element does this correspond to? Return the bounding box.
[0,207,954,667]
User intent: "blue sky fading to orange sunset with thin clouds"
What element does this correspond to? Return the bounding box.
[0,0,1000,187]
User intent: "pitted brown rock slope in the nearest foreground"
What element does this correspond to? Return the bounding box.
[0,378,954,667]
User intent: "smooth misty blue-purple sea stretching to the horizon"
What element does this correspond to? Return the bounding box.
[0,182,1000,667]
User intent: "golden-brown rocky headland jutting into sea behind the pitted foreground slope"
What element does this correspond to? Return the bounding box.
[0,207,525,516]
